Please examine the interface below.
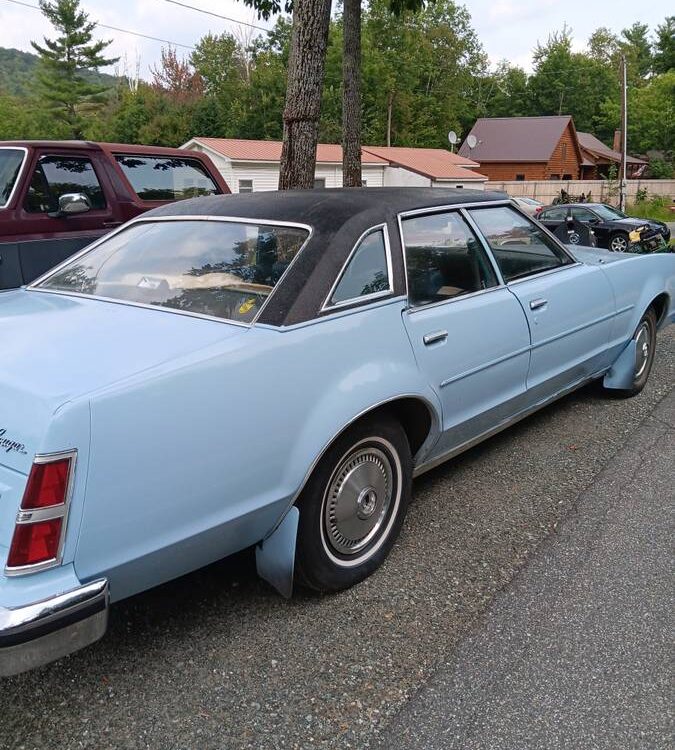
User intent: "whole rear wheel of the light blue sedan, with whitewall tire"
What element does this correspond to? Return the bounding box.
[295,415,412,592]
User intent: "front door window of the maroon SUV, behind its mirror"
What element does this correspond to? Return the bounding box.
[24,156,106,213]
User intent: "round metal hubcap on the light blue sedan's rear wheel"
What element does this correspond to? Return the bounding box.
[323,446,394,555]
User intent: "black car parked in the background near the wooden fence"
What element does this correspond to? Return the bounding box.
[537,203,670,252]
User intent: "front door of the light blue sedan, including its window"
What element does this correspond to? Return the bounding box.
[471,207,615,404]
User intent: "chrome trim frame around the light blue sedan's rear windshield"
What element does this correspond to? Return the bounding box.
[25,214,314,328]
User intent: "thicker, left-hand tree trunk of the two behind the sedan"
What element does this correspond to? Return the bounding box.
[279,0,330,190]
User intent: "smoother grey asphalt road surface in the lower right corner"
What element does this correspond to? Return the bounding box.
[372,382,675,750]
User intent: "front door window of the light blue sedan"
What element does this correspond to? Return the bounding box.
[471,206,573,282]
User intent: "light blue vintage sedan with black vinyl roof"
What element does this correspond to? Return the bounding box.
[0,189,675,675]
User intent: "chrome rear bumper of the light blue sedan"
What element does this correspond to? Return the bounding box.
[0,579,109,677]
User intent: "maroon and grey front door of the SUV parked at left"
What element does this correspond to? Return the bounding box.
[17,150,117,284]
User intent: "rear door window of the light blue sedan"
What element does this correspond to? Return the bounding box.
[402,211,499,307]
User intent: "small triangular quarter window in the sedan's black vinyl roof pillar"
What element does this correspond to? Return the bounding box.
[326,228,391,307]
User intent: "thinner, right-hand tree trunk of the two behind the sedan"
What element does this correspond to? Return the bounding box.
[342,0,361,187]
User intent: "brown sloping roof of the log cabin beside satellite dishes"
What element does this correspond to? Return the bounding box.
[459,115,572,163]
